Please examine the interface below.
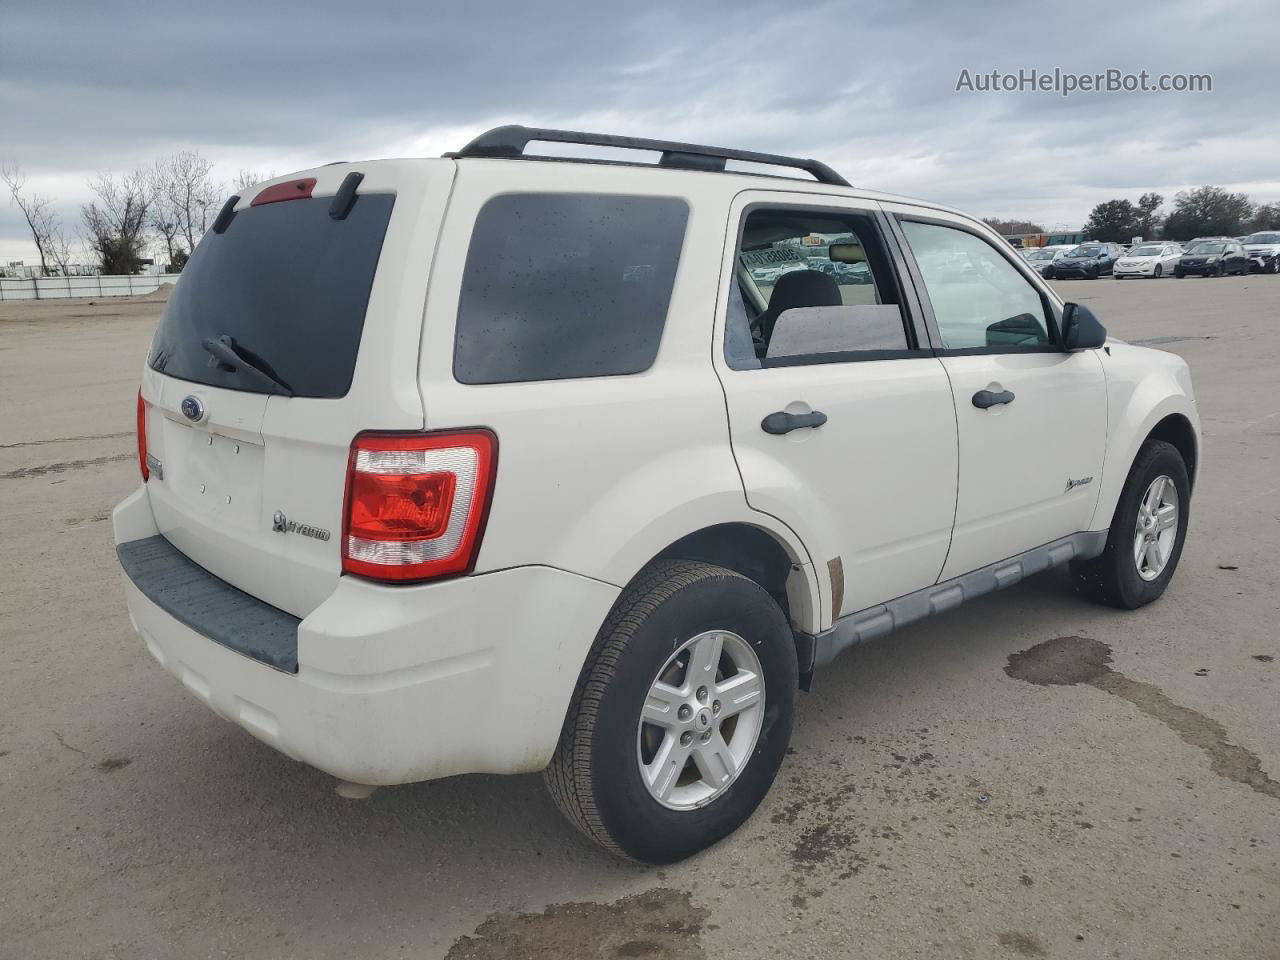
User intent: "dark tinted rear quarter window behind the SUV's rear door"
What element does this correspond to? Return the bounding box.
[453,193,689,384]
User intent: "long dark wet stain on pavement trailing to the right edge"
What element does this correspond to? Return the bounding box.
[1005,636,1280,800]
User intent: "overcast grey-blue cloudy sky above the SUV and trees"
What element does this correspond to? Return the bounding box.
[0,0,1280,262]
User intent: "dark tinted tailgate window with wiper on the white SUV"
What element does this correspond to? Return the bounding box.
[150,193,394,398]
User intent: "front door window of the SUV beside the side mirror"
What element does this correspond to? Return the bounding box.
[902,220,1051,349]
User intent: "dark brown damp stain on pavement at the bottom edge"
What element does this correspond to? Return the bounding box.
[445,888,708,960]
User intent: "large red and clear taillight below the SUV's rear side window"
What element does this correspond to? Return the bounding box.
[342,430,498,582]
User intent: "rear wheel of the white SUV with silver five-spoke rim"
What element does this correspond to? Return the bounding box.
[543,561,799,863]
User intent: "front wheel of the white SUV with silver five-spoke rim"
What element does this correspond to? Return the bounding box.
[1071,440,1190,611]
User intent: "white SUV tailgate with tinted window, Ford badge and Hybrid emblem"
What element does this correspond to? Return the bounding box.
[142,160,454,617]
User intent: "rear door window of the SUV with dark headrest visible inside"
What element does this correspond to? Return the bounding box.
[724,207,914,370]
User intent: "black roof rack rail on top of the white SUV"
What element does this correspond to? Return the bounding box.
[444,124,849,187]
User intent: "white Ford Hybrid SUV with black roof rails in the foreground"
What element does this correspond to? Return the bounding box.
[114,127,1199,861]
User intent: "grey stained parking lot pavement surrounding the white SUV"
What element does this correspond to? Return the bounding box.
[0,275,1280,960]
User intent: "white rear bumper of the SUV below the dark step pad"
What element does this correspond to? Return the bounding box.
[114,488,618,785]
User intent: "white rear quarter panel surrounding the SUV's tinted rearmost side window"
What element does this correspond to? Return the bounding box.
[420,160,817,632]
